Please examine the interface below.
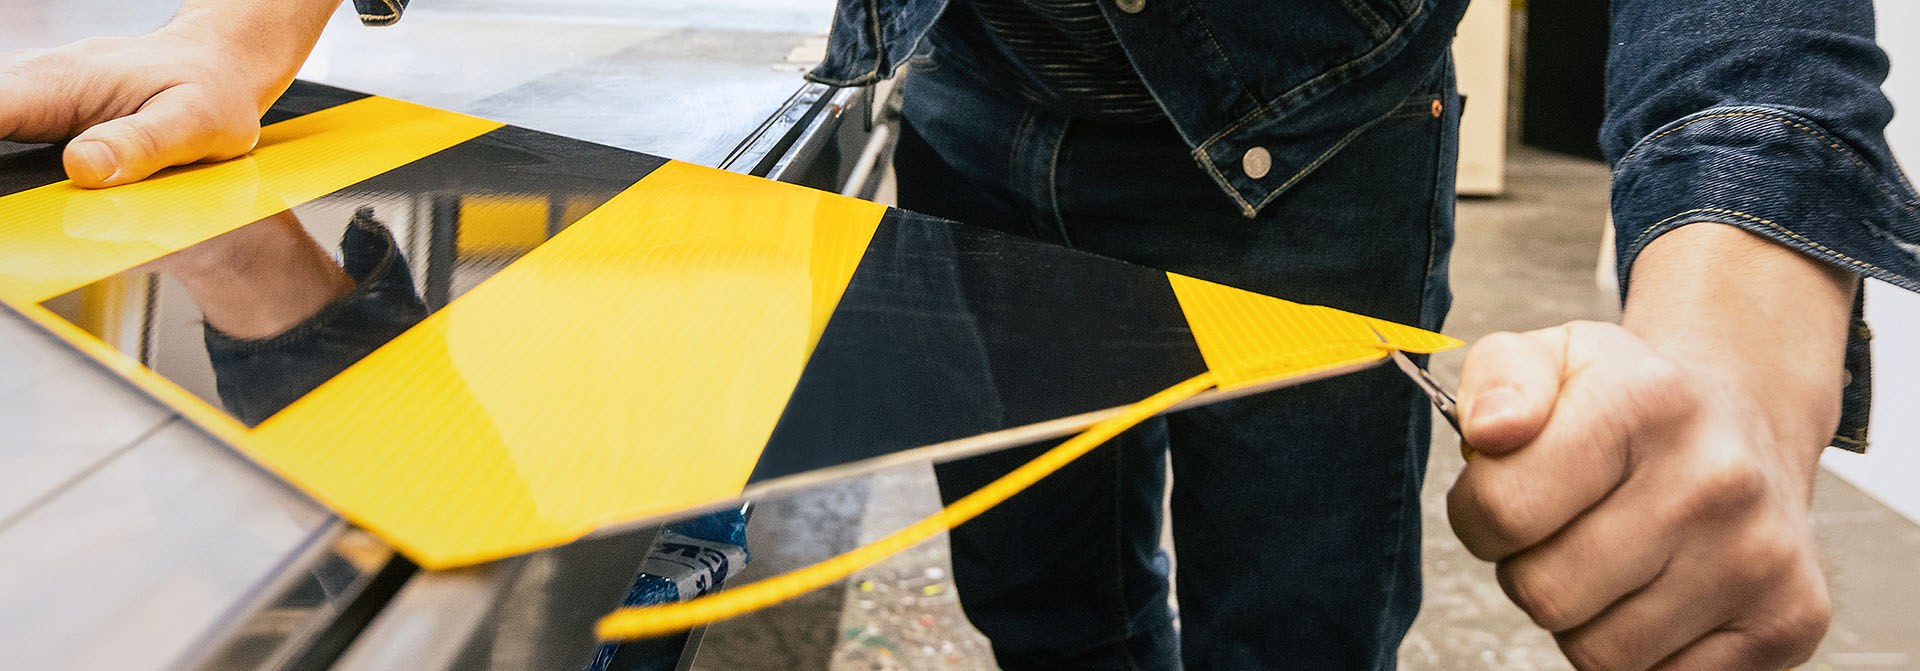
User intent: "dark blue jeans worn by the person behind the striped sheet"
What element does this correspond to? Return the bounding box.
[897,27,1461,669]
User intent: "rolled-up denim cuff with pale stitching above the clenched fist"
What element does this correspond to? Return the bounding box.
[1613,106,1920,452]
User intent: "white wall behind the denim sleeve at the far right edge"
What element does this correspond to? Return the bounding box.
[1822,0,1920,521]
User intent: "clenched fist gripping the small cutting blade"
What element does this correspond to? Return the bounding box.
[1448,321,1843,671]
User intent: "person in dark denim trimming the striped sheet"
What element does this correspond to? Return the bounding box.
[0,0,1920,669]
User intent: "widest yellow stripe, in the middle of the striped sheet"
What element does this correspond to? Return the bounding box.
[246,162,885,567]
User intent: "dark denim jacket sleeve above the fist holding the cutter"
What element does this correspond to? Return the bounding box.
[1601,0,1920,452]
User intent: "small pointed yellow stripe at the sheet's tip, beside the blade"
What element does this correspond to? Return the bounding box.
[1167,273,1461,390]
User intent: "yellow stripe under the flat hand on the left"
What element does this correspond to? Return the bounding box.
[0,98,501,304]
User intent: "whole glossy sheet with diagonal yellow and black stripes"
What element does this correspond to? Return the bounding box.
[0,85,1455,567]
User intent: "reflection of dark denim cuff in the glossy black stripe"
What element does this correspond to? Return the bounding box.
[205,208,426,427]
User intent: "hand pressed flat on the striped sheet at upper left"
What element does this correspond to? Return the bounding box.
[0,0,338,188]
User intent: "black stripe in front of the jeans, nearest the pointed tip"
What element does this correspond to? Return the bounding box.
[751,210,1206,481]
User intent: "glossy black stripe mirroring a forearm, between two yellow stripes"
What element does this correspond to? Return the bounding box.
[35,83,666,425]
